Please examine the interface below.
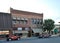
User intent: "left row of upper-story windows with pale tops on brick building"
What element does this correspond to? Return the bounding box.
[12,16,28,24]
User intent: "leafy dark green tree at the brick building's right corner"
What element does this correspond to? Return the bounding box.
[43,19,54,33]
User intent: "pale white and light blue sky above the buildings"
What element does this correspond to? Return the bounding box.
[0,0,60,24]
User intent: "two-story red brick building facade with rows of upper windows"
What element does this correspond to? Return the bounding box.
[10,8,43,37]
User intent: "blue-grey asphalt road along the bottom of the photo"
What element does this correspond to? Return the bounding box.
[0,37,60,43]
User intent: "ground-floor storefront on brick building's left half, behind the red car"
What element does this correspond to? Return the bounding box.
[13,27,28,37]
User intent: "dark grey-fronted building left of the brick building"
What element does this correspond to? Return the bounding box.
[0,12,12,37]
